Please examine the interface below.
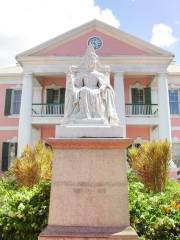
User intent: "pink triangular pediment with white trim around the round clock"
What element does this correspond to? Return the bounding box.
[16,20,173,60]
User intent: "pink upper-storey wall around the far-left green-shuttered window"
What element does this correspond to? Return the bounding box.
[0,84,19,126]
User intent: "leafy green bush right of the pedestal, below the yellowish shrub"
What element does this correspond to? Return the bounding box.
[128,173,180,240]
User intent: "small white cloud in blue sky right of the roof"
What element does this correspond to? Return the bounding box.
[151,23,178,48]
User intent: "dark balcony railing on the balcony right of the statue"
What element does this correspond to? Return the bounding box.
[126,104,158,116]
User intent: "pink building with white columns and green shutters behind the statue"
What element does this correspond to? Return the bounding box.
[0,20,180,170]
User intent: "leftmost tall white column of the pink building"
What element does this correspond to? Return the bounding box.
[18,73,32,156]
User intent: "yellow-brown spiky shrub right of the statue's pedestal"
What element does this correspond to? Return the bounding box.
[129,141,171,192]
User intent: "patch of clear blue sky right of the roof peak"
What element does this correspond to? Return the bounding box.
[95,0,180,64]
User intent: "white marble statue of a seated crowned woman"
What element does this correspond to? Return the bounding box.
[64,45,119,125]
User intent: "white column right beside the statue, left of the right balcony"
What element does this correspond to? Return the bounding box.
[114,72,126,137]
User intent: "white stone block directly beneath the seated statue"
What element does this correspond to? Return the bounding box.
[55,125,125,138]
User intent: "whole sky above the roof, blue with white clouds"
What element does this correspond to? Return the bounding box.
[0,0,180,67]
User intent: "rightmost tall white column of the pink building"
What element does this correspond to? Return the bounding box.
[158,73,171,141]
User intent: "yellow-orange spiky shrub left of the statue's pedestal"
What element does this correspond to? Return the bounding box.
[10,142,53,187]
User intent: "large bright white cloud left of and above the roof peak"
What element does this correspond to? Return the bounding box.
[0,0,120,66]
